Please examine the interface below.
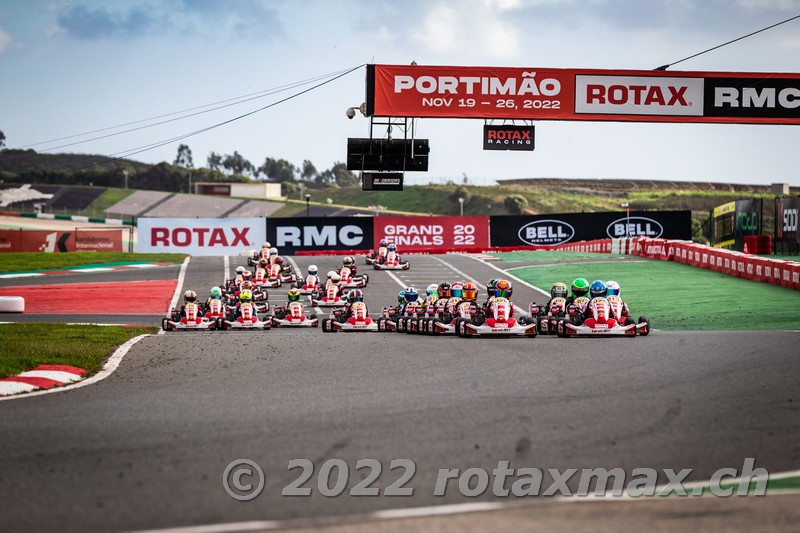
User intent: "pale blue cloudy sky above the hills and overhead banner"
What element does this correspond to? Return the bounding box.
[0,0,800,185]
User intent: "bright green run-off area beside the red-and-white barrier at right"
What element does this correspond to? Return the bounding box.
[506,252,800,331]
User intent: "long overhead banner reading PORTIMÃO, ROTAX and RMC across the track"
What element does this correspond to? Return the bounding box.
[366,65,800,124]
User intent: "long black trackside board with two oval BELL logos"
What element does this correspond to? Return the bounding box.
[489,211,692,246]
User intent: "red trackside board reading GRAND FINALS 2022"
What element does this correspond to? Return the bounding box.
[373,216,489,253]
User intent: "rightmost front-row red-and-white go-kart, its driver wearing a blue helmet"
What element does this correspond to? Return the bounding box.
[557,296,650,337]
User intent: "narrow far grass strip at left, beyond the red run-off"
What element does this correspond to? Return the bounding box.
[0,252,186,272]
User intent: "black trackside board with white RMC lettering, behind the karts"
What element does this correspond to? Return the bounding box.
[262,217,372,255]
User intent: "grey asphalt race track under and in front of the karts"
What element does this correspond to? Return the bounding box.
[0,255,800,531]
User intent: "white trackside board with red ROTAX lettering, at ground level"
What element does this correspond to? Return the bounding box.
[138,217,267,255]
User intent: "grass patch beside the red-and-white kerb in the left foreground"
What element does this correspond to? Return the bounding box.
[0,323,157,377]
